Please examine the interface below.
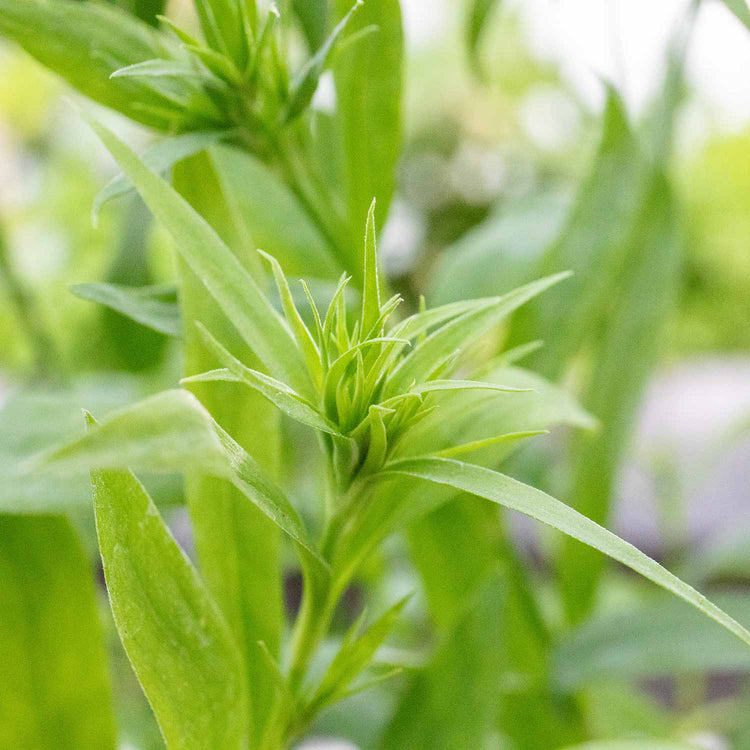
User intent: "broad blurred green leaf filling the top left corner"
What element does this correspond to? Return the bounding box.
[0,0,206,131]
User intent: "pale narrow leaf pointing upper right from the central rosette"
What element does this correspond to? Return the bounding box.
[386,273,569,396]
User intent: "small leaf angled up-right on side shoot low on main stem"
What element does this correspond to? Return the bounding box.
[307,596,409,715]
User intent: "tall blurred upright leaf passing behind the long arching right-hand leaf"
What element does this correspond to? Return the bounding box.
[560,174,680,621]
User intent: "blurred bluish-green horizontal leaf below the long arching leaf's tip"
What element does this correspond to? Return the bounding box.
[552,594,750,690]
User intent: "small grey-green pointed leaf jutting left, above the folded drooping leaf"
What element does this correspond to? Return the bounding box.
[70,284,182,337]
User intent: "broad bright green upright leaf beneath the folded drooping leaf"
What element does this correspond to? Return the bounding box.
[87,416,249,750]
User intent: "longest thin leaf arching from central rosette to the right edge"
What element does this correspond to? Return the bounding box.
[383,456,750,646]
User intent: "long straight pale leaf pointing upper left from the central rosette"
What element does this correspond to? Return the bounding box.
[81,112,312,396]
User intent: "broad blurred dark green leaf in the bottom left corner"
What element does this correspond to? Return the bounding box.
[0,516,116,750]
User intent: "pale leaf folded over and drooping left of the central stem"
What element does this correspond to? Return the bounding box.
[34,390,319,558]
